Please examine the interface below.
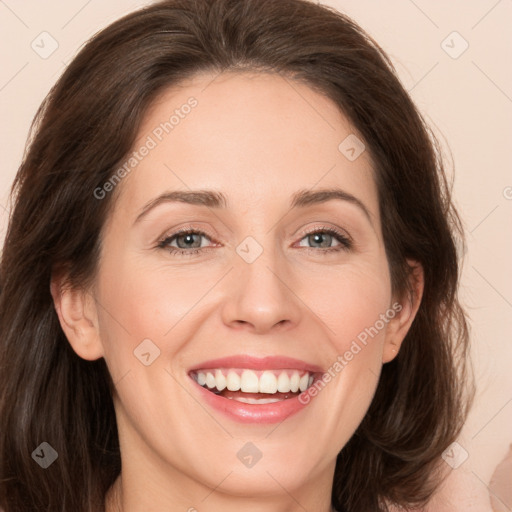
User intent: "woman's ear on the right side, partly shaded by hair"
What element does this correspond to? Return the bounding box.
[382,260,425,363]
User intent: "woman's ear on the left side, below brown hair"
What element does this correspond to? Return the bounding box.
[50,275,103,361]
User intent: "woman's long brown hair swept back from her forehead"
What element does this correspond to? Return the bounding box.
[0,0,472,512]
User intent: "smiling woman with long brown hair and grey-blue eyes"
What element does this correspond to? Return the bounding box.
[0,0,471,512]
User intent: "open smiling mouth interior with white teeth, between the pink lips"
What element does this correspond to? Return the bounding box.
[189,368,316,405]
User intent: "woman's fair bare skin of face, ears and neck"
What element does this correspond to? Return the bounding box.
[52,73,423,512]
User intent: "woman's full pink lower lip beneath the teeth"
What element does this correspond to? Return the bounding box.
[190,377,313,423]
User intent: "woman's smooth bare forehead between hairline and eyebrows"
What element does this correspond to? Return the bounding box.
[113,73,378,222]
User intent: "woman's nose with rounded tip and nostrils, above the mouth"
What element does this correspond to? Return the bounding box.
[222,242,301,334]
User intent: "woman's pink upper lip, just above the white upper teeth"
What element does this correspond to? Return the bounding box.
[189,354,323,373]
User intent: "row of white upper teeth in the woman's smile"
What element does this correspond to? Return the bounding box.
[195,369,313,393]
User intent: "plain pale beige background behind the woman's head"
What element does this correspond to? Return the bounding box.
[0,0,512,504]
